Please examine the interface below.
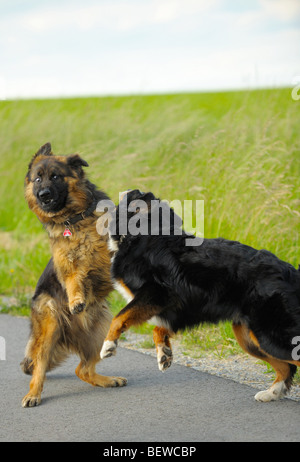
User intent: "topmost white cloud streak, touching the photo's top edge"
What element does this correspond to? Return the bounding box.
[12,0,220,32]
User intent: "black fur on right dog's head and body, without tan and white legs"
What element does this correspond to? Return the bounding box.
[110,190,300,360]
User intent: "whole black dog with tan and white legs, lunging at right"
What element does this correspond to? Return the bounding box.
[101,190,300,401]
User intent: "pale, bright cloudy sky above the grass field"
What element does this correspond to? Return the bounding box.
[0,0,300,99]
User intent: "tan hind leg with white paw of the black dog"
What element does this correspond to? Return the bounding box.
[232,324,297,402]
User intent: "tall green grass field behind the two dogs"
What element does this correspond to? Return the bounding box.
[0,89,300,364]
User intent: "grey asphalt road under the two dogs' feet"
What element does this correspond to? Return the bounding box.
[0,314,300,444]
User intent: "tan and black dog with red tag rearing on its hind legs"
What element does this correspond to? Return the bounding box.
[21,143,127,407]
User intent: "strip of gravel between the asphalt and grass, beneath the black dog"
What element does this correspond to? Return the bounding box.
[119,331,300,401]
